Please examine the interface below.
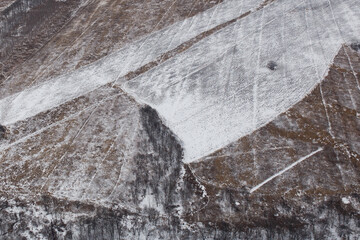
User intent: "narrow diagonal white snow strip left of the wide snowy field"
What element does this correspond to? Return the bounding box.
[0,0,262,125]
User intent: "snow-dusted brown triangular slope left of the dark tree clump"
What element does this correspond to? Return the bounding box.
[0,87,181,216]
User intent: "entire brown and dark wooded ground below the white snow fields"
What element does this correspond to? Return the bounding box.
[0,43,360,239]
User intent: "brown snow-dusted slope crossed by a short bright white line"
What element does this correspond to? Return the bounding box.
[189,46,360,236]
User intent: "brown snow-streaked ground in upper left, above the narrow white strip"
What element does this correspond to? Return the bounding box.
[0,0,221,98]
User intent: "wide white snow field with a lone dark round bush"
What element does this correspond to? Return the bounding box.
[124,0,360,162]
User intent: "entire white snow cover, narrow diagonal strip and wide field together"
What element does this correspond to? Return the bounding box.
[0,0,360,162]
